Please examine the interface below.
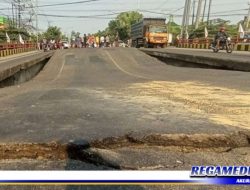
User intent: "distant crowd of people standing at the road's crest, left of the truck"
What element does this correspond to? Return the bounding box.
[71,34,111,48]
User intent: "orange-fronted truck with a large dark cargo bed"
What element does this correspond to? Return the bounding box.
[131,18,168,48]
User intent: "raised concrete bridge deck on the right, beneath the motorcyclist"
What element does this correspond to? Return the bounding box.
[140,48,250,71]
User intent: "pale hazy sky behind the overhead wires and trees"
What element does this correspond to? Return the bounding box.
[0,0,249,34]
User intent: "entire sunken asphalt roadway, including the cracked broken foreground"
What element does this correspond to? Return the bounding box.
[0,48,250,190]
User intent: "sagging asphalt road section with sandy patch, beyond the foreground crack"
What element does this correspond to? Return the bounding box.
[0,48,250,143]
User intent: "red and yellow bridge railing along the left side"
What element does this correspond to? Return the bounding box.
[0,42,37,57]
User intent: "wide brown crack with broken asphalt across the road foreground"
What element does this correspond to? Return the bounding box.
[0,131,250,170]
